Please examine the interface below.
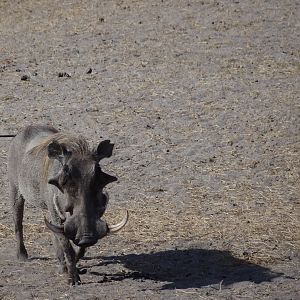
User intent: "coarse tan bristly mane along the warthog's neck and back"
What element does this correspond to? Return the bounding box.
[29,133,91,179]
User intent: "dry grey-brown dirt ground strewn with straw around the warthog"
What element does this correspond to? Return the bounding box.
[0,0,300,300]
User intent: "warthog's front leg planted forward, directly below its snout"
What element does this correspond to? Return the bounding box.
[56,236,80,285]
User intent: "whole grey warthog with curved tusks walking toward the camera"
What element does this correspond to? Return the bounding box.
[8,125,128,285]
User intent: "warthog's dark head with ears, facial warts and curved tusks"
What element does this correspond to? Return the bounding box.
[45,140,128,247]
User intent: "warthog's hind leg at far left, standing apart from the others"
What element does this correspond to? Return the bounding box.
[10,187,28,260]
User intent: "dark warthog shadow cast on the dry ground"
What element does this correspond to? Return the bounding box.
[82,249,283,289]
